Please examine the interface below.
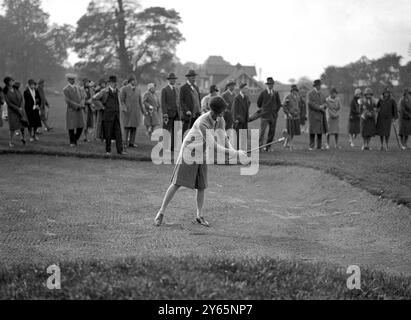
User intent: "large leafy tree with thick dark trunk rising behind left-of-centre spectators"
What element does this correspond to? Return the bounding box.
[74,0,184,81]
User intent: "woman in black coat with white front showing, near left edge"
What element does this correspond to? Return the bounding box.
[24,79,41,141]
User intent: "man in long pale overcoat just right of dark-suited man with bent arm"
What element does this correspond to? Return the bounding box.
[120,75,144,148]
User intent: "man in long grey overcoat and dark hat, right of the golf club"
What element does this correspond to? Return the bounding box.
[307,80,328,150]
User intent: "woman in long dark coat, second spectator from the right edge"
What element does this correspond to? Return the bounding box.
[376,88,398,151]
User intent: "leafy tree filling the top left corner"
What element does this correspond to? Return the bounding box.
[0,0,72,82]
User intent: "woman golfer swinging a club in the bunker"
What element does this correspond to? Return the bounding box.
[154,96,246,227]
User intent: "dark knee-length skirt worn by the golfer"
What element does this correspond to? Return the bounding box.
[171,163,208,190]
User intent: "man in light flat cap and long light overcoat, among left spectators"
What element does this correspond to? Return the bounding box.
[63,73,85,147]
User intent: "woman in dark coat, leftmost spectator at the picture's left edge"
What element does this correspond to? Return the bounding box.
[3,77,27,148]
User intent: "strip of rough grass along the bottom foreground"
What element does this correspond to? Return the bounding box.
[0,256,411,300]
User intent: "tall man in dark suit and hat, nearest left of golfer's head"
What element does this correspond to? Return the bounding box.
[180,70,201,133]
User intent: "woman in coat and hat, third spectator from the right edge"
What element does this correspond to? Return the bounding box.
[360,88,377,151]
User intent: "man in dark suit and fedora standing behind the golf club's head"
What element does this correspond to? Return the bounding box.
[257,78,281,152]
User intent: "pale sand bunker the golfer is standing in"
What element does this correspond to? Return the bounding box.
[0,155,411,275]
